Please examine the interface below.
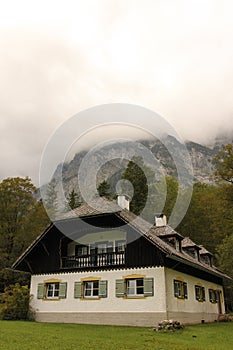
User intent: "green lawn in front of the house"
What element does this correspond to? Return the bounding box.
[0,321,233,350]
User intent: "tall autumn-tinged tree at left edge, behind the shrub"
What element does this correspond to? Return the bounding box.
[0,177,48,291]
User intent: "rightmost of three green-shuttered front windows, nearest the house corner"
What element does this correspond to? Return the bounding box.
[116,278,154,298]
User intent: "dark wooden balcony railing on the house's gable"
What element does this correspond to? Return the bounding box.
[62,252,125,269]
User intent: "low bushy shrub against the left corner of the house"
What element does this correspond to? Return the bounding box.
[0,283,33,320]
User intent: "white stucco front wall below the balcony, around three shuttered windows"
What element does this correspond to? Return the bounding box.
[31,267,166,313]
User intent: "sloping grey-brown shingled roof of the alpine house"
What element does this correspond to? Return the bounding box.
[12,198,229,279]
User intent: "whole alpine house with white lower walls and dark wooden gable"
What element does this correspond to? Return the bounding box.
[13,197,227,326]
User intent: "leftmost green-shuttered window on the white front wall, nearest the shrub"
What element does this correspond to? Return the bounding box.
[37,281,67,300]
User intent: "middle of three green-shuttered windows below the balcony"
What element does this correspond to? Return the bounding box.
[74,280,108,299]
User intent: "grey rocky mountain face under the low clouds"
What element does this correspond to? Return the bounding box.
[44,135,233,202]
